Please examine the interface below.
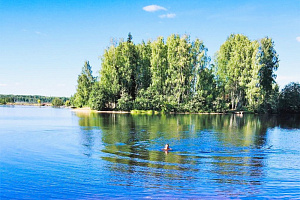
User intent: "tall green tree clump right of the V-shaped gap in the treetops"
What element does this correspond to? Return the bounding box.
[216,34,279,112]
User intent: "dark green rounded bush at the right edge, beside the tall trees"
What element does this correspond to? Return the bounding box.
[279,82,300,113]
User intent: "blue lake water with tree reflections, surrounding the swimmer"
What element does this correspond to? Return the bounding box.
[0,106,300,199]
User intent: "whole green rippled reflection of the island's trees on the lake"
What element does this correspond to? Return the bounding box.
[77,113,299,196]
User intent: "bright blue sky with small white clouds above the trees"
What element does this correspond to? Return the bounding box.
[0,0,300,96]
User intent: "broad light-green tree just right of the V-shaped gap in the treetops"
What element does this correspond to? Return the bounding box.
[216,34,254,109]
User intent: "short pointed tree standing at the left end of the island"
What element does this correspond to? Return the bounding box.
[74,61,95,107]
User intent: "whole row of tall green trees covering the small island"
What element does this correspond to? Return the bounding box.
[71,34,298,113]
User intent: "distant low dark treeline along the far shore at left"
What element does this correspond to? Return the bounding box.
[0,94,70,104]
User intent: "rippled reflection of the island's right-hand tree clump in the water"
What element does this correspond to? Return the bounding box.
[207,115,274,194]
